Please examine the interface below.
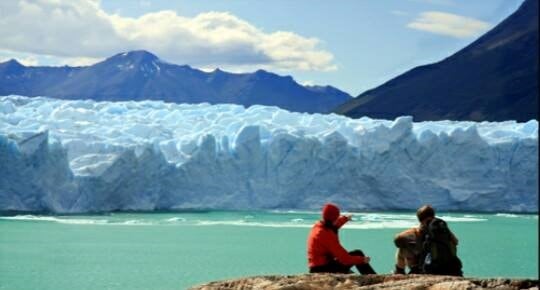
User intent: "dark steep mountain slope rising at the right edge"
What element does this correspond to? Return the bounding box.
[334,0,538,121]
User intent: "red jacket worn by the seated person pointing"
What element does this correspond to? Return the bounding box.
[307,216,365,268]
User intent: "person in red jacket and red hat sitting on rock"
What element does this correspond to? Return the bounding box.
[307,203,375,274]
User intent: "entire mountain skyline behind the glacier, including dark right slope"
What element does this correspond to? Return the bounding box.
[0,0,538,121]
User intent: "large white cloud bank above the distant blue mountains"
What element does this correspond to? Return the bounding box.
[0,0,336,71]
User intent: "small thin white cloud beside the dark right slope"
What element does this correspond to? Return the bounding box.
[407,11,490,38]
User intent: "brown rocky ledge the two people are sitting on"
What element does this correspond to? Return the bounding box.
[191,274,539,290]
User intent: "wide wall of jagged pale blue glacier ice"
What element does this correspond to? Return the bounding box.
[0,95,538,213]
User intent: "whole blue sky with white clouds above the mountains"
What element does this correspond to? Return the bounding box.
[0,0,523,96]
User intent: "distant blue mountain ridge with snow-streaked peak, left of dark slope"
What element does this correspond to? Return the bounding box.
[0,50,351,113]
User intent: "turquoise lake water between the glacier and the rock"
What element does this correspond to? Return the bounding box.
[0,211,538,290]
